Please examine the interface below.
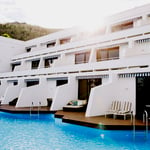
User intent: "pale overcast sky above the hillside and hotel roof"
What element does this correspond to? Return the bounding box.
[0,0,150,28]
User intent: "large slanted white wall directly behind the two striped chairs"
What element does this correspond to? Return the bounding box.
[86,75,135,117]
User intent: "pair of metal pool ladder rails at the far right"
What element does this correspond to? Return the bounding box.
[132,110,149,139]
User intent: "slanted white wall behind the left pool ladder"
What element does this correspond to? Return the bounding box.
[16,78,48,107]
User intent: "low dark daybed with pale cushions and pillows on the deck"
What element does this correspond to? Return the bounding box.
[63,100,87,111]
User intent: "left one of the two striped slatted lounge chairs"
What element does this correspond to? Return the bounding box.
[105,101,121,118]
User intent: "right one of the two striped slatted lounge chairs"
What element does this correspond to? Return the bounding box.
[113,101,132,121]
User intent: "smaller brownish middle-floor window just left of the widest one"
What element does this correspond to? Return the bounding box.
[75,52,90,64]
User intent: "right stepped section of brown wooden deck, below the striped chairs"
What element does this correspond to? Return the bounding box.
[55,111,150,130]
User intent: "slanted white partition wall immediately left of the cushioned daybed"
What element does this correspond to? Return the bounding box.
[51,76,78,110]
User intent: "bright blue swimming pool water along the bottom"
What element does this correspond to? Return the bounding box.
[0,112,150,150]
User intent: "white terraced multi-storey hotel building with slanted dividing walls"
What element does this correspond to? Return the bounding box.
[0,5,150,116]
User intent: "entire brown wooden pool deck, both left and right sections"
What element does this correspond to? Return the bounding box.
[0,105,150,130]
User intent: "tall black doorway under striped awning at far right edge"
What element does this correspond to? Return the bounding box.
[136,77,150,119]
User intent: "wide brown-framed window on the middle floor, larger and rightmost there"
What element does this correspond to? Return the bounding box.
[96,47,119,61]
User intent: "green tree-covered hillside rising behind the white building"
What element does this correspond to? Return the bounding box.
[0,22,60,41]
